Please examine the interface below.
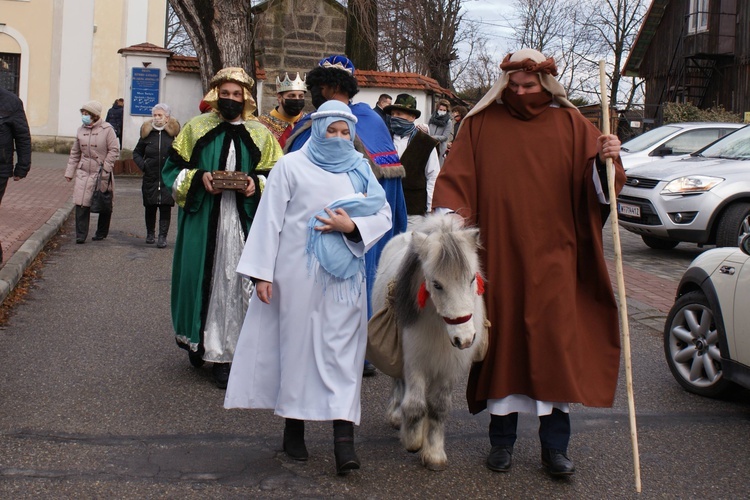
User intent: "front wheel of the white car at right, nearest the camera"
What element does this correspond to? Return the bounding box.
[664,291,732,397]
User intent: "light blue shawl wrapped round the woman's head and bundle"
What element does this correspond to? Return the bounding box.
[303,101,385,299]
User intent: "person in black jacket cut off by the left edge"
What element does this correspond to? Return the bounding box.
[0,88,31,262]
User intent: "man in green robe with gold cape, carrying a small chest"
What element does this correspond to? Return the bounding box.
[162,68,282,389]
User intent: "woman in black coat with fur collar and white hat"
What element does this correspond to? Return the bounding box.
[133,104,180,248]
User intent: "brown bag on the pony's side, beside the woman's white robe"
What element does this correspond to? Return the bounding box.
[365,281,404,378]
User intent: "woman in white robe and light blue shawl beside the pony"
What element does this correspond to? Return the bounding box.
[224,101,391,473]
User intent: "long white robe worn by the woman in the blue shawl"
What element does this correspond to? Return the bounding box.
[224,150,391,424]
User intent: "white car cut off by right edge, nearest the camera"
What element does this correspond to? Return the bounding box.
[664,235,750,397]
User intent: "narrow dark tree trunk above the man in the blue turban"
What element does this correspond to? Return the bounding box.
[346,0,378,70]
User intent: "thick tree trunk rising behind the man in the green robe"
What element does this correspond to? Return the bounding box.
[169,0,255,92]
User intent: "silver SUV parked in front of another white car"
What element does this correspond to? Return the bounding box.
[617,126,750,249]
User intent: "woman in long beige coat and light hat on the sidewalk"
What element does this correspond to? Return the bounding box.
[65,101,120,243]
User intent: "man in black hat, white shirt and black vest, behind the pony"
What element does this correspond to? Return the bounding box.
[384,94,440,224]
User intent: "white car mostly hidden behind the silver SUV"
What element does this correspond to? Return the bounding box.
[620,122,743,170]
